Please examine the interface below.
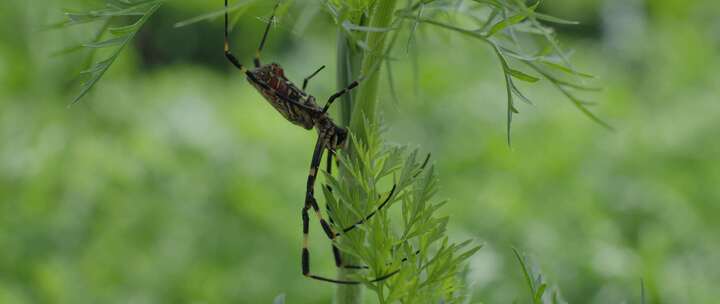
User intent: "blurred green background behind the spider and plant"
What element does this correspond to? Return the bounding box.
[0,0,720,303]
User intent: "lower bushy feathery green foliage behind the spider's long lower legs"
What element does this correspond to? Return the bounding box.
[324,123,480,303]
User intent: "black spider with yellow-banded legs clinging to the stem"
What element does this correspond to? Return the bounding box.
[225,0,404,284]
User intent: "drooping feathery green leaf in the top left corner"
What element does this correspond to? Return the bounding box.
[56,0,165,104]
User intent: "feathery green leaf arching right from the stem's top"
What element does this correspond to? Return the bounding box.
[388,0,611,143]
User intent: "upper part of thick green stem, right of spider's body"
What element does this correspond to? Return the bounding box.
[350,0,397,140]
